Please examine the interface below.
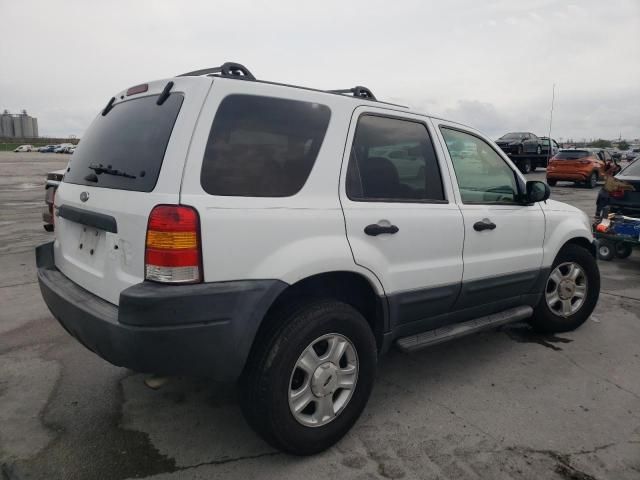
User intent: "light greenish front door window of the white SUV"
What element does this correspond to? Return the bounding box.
[441,127,518,204]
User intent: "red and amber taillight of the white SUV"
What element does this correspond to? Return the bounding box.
[145,205,202,283]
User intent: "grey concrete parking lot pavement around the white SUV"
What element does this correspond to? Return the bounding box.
[0,152,640,480]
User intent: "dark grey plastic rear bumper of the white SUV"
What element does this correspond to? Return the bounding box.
[36,243,287,381]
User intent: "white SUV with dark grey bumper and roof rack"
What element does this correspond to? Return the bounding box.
[37,64,600,454]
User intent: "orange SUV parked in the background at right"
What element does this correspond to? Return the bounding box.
[547,149,605,188]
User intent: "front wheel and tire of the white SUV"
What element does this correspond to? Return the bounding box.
[529,244,600,333]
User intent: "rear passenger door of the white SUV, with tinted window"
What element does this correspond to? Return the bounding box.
[340,107,464,329]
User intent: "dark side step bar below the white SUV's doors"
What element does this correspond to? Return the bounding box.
[396,306,533,353]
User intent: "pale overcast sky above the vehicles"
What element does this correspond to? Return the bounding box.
[0,0,640,139]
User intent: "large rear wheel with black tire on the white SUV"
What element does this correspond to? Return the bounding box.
[240,300,377,455]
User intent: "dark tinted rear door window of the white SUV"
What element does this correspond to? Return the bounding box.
[346,115,445,202]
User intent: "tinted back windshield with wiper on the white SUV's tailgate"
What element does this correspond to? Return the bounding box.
[64,93,184,192]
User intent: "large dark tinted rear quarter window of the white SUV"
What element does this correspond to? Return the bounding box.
[200,95,331,197]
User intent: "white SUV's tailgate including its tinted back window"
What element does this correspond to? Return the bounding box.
[54,77,212,304]
